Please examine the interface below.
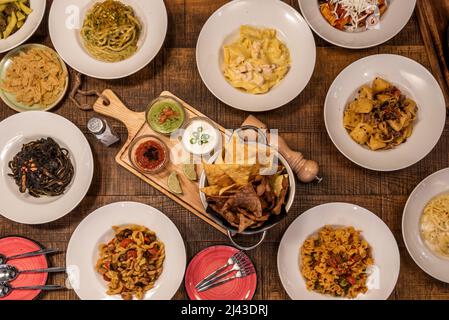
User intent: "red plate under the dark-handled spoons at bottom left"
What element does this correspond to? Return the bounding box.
[0,236,48,301]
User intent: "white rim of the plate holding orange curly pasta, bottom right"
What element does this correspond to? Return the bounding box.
[277,202,400,300]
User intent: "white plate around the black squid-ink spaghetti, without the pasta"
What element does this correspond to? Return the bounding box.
[0,111,94,224]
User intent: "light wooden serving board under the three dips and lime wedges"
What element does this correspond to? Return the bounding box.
[93,90,226,234]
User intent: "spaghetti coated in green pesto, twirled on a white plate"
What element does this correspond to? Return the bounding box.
[81,0,142,62]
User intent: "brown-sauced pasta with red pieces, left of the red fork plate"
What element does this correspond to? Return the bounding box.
[96,225,165,300]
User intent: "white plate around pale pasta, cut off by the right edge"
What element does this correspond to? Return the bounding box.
[402,168,449,283]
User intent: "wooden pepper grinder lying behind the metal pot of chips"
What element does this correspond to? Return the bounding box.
[242,116,323,183]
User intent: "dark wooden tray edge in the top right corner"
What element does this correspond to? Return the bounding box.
[416,0,449,107]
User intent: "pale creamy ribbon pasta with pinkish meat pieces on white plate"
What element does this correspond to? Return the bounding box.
[223,26,290,94]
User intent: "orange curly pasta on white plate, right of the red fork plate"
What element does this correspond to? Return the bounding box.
[301,226,374,298]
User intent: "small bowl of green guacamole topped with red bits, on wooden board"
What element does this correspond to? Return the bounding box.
[146,96,186,135]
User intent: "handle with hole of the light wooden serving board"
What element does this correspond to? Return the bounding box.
[93,89,145,139]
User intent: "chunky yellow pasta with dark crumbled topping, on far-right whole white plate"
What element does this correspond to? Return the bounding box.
[343,78,418,150]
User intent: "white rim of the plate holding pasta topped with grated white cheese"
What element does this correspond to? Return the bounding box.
[298,0,416,49]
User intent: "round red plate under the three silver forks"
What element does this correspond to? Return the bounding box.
[184,246,257,300]
